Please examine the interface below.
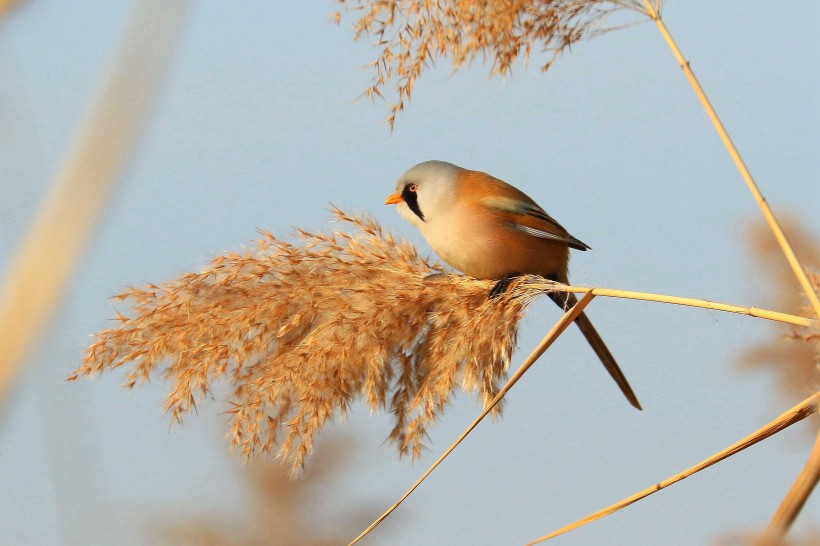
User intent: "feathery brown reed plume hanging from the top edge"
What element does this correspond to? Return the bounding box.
[336,0,661,127]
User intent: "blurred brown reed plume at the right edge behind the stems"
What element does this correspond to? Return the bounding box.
[742,218,820,400]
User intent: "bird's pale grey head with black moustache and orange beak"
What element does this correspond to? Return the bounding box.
[388,161,464,228]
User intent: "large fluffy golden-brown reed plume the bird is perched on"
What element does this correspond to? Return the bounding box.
[69,209,550,471]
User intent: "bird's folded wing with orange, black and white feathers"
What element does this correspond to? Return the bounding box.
[481,190,589,250]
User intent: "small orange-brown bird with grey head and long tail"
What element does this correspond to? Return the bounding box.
[384,161,642,410]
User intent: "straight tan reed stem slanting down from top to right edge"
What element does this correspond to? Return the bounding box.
[644,0,820,318]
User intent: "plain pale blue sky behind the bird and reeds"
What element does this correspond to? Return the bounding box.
[0,0,820,545]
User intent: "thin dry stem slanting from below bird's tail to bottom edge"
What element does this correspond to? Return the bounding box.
[348,292,594,546]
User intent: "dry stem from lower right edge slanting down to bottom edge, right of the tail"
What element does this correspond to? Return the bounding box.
[529,392,820,544]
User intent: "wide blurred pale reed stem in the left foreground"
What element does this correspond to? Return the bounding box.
[0,0,183,399]
